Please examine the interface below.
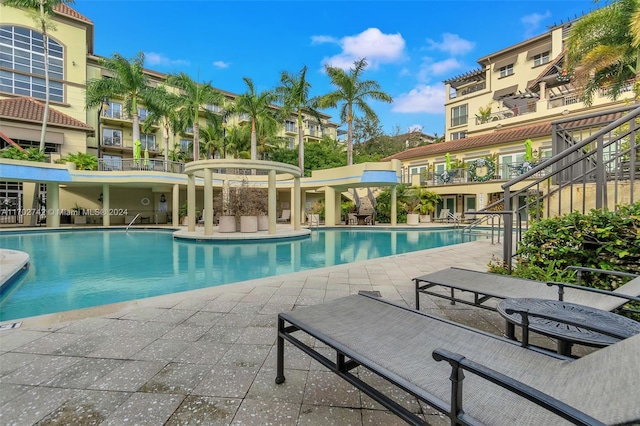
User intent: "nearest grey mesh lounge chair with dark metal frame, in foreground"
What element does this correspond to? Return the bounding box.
[276,295,640,425]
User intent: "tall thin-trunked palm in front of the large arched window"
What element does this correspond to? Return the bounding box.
[2,0,74,153]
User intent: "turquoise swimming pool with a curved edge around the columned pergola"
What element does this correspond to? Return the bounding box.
[0,229,476,320]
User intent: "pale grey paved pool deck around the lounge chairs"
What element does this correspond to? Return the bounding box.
[0,240,551,425]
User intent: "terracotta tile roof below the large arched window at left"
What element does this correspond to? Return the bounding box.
[0,97,93,131]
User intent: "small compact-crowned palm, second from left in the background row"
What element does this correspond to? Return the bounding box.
[142,86,183,167]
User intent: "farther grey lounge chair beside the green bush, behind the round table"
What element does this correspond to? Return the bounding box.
[413,267,640,311]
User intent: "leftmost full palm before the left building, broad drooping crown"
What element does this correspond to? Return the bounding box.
[86,52,153,149]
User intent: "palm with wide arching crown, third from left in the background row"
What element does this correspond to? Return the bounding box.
[167,73,224,160]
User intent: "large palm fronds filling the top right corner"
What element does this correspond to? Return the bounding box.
[565,0,640,105]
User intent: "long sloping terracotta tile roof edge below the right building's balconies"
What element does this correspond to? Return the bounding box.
[382,112,622,161]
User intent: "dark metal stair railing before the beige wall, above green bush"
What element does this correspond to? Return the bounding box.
[500,104,640,268]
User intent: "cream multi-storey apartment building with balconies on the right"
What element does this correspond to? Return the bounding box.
[388,17,633,220]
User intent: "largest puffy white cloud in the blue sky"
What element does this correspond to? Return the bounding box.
[316,28,405,69]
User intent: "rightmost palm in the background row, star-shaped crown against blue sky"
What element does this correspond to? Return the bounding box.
[317,58,393,165]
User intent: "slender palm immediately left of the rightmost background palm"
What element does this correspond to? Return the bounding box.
[276,65,322,176]
